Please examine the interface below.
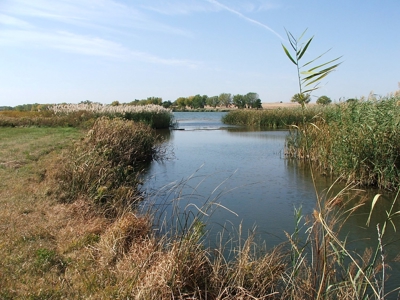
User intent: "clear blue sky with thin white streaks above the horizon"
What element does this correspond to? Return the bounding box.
[0,0,400,106]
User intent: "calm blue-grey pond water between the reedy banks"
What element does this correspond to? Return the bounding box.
[144,113,400,296]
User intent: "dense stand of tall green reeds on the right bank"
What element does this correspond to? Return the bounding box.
[286,97,400,189]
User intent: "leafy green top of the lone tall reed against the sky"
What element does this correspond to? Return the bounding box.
[282,29,341,106]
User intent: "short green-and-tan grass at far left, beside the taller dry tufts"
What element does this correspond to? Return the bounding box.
[0,128,82,299]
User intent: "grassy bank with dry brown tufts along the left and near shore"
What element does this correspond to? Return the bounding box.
[0,118,394,299]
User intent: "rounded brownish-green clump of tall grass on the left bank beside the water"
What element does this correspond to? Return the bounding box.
[57,117,162,217]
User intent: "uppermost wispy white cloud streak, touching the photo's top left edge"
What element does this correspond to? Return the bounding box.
[0,0,191,36]
